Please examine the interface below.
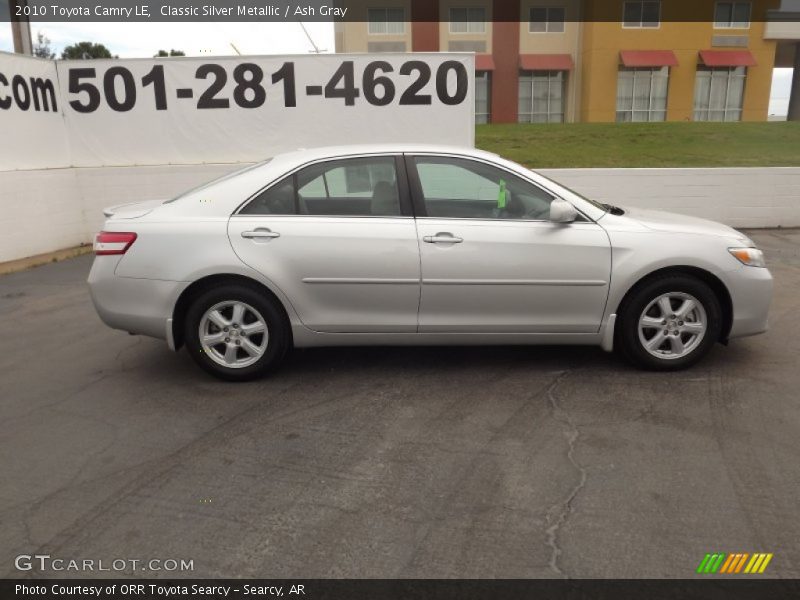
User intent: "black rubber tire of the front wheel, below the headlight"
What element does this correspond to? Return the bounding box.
[616,274,722,371]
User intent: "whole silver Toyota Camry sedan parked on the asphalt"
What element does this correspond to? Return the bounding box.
[89,145,772,380]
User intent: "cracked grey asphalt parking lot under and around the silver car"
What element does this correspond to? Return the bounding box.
[0,230,800,578]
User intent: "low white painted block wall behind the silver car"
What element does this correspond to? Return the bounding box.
[0,164,800,262]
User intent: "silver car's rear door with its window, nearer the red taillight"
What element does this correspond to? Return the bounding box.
[228,155,420,333]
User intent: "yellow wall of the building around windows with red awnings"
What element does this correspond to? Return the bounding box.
[580,0,777,122]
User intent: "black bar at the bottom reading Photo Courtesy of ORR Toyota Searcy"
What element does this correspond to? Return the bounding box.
[0,576,800,600]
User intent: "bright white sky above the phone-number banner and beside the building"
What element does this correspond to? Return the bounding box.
[0,21,800,115]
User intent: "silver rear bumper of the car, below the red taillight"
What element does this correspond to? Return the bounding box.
[89,256,189,340]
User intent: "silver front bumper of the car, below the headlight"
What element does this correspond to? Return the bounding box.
[728,266,772,339]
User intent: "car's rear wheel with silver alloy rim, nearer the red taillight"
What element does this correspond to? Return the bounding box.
[184,285,290,381]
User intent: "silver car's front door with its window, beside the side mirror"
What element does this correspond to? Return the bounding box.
[406,154,611,333]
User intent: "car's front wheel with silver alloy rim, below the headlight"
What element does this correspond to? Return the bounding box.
[619,275,722,371]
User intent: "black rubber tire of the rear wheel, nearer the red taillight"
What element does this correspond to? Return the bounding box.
[184,284,291,381]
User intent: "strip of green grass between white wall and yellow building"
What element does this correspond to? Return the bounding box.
[476,121,800,168]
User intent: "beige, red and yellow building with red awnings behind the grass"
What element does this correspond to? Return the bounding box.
[336,0,800,123]
